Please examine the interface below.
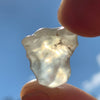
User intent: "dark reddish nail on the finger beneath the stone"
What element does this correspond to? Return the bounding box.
[22,91,50,100]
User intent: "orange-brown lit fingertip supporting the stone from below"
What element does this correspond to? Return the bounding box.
[21,80,97,100]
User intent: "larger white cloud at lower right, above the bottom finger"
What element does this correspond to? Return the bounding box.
[82,72,100,92]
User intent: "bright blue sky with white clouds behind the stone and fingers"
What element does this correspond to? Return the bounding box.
[0,0,100,100]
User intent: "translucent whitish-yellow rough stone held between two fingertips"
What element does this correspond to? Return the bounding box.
[22,27,78,88]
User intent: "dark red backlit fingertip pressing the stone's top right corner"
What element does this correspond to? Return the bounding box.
[58,0,100,37]
